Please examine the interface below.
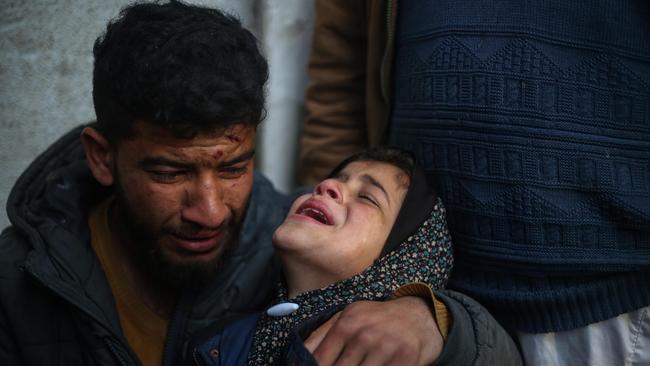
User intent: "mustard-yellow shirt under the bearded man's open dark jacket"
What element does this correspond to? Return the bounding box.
[88,198,169,366]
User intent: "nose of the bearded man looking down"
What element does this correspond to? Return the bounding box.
[181,177,228,229]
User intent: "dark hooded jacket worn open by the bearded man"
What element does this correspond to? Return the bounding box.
[0,126,291,365]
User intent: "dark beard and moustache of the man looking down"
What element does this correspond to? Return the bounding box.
[115,180,241,290]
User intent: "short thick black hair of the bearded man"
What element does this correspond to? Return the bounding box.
[93,1,268,141]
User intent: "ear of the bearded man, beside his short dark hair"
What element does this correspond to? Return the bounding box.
[81,127,115,186]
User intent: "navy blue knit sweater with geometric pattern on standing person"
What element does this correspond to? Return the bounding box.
[390,0,650,332]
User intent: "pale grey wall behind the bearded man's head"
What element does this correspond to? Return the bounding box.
[0,0,313,228]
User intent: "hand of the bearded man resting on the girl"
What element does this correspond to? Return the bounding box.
[305,297,443,366]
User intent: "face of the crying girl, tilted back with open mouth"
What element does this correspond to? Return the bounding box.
[273,161,409,280]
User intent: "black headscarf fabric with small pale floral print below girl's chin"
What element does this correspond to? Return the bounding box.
[247,199,452,365]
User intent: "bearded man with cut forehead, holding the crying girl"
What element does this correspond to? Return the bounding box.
[0,2,512,365]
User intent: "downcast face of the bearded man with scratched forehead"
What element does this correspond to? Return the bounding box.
[113,121,255,284]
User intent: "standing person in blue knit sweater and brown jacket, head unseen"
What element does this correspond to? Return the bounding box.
[301,0,650,365]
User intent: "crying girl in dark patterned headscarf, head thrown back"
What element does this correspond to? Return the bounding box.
[188,147,521,365]
